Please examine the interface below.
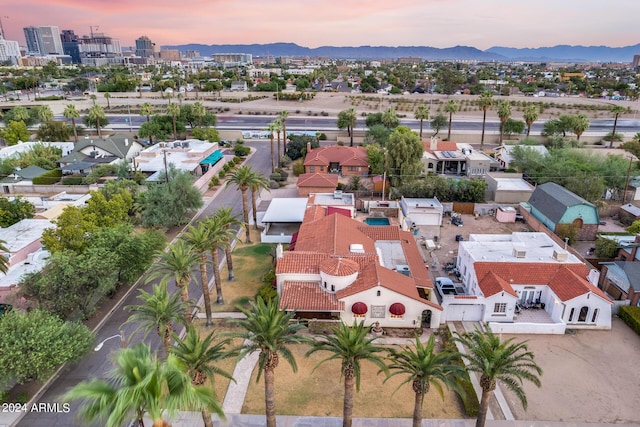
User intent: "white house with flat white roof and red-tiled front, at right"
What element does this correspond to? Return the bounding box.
[448,232,612,334]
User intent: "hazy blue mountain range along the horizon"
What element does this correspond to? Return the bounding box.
[163,43,640,62]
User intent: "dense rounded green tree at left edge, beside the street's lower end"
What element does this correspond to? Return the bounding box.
[0,309,94,387]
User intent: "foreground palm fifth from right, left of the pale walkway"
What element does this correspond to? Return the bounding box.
[171,325,237,427]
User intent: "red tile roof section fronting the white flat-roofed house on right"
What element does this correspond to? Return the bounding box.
[474,262,611,302]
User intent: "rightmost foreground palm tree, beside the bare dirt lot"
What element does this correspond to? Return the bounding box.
[456,328,542,427]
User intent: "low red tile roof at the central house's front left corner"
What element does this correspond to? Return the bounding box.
[280,280,344,311]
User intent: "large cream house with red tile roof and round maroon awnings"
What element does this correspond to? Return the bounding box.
[276,205,442,328]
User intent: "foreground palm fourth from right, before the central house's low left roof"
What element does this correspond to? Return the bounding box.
[229,296,304,427]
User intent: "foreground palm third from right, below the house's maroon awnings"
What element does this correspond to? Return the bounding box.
[306,321,387,427]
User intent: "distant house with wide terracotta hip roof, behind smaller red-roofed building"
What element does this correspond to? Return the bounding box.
[304,145,369,176]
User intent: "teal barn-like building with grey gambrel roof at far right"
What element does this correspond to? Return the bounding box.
[528,182,600,240]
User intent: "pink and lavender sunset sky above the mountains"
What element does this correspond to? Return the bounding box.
[0,0,640,49]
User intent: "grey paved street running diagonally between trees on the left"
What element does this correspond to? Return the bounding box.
[17,142,271,427]
